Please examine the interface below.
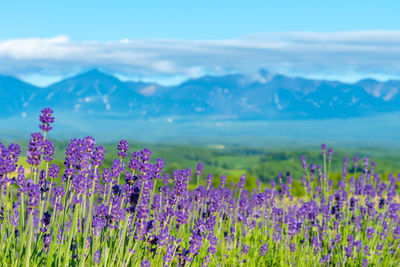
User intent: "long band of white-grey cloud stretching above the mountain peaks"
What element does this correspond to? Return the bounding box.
[0,31,400,83]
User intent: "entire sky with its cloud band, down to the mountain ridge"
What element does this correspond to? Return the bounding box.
[0,0,400,85]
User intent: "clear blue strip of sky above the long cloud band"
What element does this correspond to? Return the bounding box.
[0,0,400,41]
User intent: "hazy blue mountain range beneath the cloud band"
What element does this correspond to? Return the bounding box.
[0,69,400,120]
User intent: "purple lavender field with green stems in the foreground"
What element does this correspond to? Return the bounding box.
[0,108,400,266]
